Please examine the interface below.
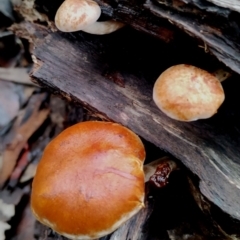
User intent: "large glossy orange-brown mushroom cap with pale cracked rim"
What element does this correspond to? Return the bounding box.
[31,121,145,239]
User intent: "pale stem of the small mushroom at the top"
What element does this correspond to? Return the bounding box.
[82,20,125,35]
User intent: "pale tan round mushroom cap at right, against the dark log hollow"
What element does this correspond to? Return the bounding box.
[153,64,225,121]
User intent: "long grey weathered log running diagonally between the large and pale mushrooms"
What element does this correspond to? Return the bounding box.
[13,21,240,223]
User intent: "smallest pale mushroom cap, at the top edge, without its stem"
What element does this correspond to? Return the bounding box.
[55,0,101,32]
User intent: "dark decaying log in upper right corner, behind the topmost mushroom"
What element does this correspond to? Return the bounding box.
[36,0,240,73]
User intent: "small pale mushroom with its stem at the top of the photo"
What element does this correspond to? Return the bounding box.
[55,0,124,35]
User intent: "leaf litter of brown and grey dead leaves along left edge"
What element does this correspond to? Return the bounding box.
[0,0,69,240]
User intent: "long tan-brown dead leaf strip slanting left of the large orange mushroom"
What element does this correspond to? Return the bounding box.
[0,93,49,186]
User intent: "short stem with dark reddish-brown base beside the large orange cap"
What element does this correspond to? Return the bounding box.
[143,157,177,188]
